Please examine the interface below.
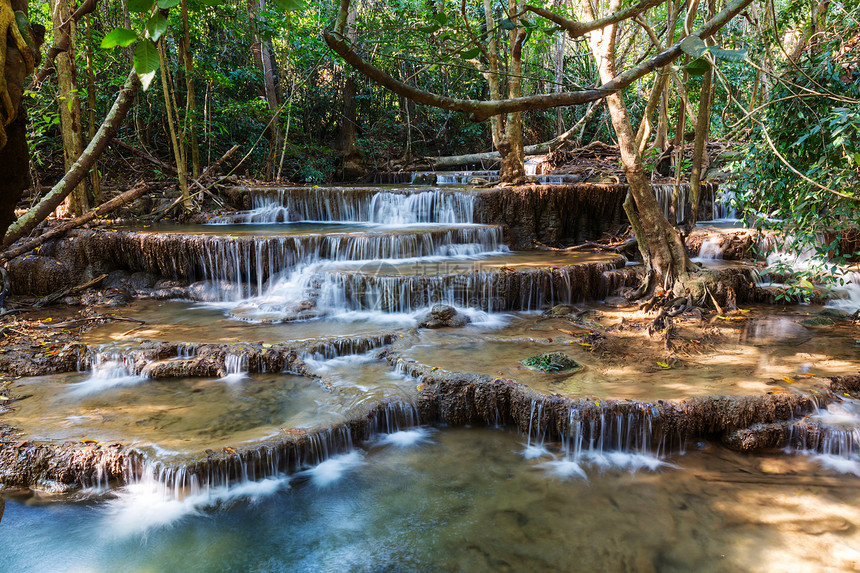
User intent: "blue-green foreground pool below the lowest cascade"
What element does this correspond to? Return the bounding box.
[0,429,860,572]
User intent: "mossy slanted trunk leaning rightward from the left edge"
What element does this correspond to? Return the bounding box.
[0,71,140,247]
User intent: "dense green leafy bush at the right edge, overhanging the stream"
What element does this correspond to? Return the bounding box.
[735,4,860,296]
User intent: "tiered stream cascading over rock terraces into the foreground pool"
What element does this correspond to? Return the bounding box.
[0,181,860,572]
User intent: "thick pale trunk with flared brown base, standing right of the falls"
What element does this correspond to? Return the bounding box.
[586,0,689,289]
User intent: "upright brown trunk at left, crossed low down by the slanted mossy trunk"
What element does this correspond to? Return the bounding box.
[51,0,89,217]
